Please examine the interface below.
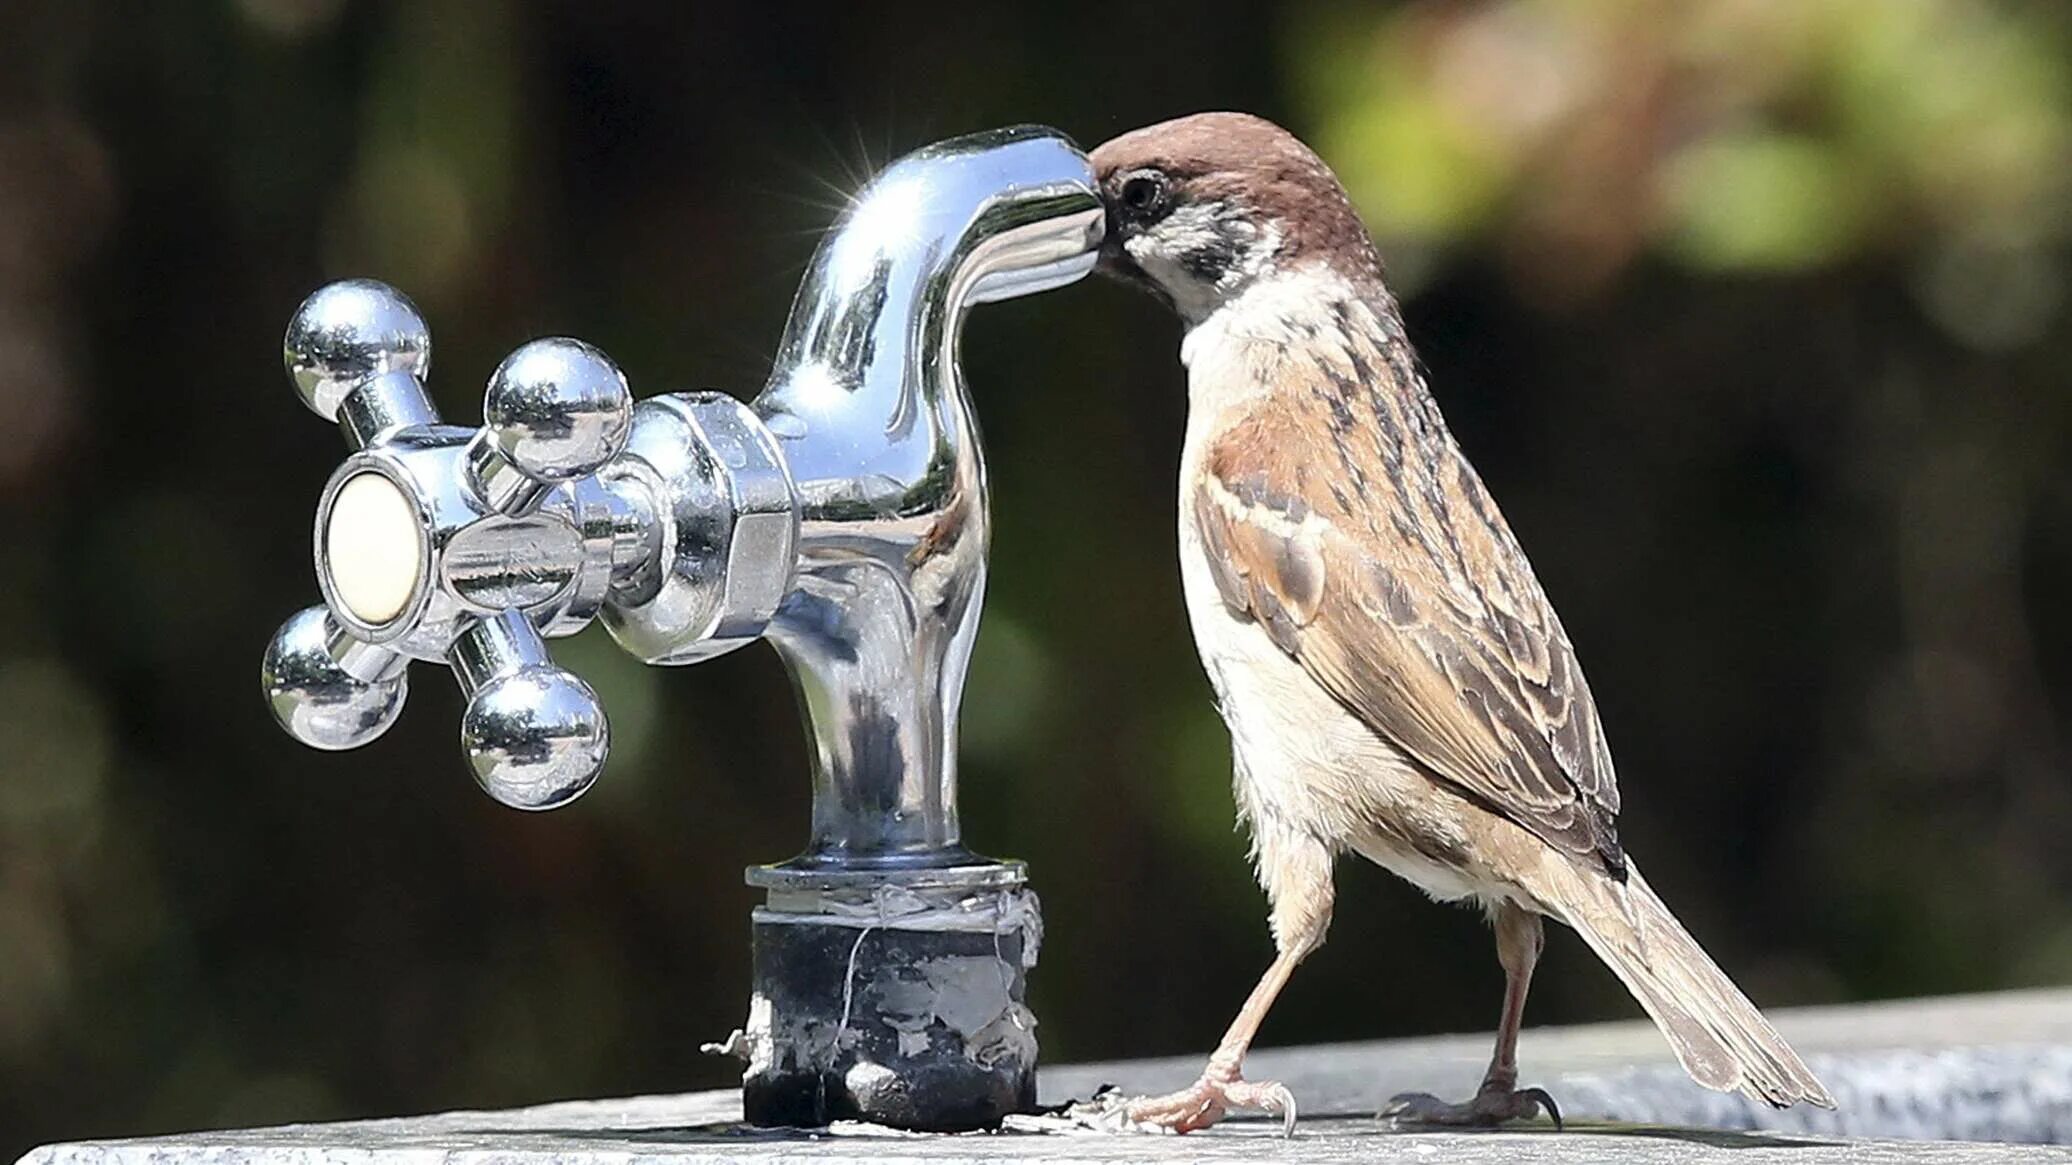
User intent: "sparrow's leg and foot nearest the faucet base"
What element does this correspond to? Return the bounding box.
[1125,823,1332,1136]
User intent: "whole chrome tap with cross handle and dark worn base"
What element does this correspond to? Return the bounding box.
[261,126,1104,1128]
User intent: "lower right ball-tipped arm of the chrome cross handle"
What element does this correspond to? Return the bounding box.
[448,612,611,808]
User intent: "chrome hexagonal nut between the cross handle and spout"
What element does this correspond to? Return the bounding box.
[601,392,798,663]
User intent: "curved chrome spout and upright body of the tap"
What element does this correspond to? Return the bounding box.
[754,126,1104,869]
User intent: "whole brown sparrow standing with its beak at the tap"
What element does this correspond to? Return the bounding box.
[1092,112,1834,1132]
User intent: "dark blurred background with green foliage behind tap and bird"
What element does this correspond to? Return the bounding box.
[0,0,2072,1159]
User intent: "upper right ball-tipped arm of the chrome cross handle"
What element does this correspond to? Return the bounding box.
[468,338,634,518]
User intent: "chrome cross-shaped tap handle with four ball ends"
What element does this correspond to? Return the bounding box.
[261,280,632,808]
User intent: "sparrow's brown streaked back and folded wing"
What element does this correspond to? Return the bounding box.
[1191,331,1624,875]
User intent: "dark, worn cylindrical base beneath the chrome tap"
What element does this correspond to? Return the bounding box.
[742,862,1042,1132]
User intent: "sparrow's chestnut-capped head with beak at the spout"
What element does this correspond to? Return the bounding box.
[1092,114,1380,325]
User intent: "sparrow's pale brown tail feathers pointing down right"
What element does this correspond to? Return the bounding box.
[1531,862,1834,1109]
